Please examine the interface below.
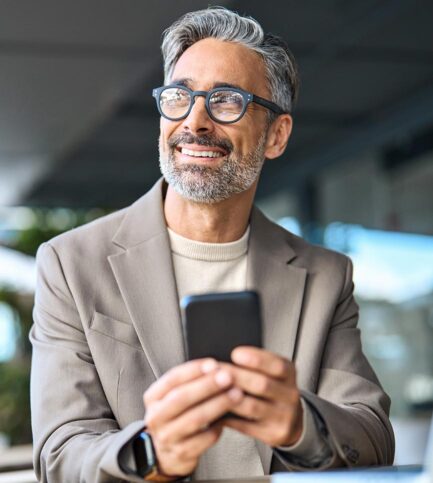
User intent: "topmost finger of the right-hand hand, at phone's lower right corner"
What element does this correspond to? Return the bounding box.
[231,346,294,380]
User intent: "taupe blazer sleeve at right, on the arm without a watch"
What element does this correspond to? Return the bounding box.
[273,259,394,471]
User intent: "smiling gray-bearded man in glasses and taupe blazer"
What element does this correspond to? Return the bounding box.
[31,8,393,482]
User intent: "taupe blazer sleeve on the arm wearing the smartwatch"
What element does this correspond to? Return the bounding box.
[30,243,144,483]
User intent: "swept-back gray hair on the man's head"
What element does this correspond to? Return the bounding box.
[161,7,299,114]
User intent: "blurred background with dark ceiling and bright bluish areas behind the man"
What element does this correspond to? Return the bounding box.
[0,0,433,476]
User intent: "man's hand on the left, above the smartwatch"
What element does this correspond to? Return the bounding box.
[144,359,243,476]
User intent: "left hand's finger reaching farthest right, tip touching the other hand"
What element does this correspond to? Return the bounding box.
[158,388,243,443]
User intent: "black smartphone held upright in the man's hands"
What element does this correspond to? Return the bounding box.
[181,291,262,362]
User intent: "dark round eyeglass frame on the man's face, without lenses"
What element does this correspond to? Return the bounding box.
[152,84,287,124]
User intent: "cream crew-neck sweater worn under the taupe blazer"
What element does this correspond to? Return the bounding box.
[168,227,322,480]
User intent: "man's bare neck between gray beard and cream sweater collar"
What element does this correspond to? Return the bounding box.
[164,182,257,243]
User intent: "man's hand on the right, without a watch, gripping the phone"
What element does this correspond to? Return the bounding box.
[223,347,303,446]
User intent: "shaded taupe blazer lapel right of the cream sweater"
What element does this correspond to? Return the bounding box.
[247,209,307,474]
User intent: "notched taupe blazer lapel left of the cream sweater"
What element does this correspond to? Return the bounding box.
[108,180,185,378]
